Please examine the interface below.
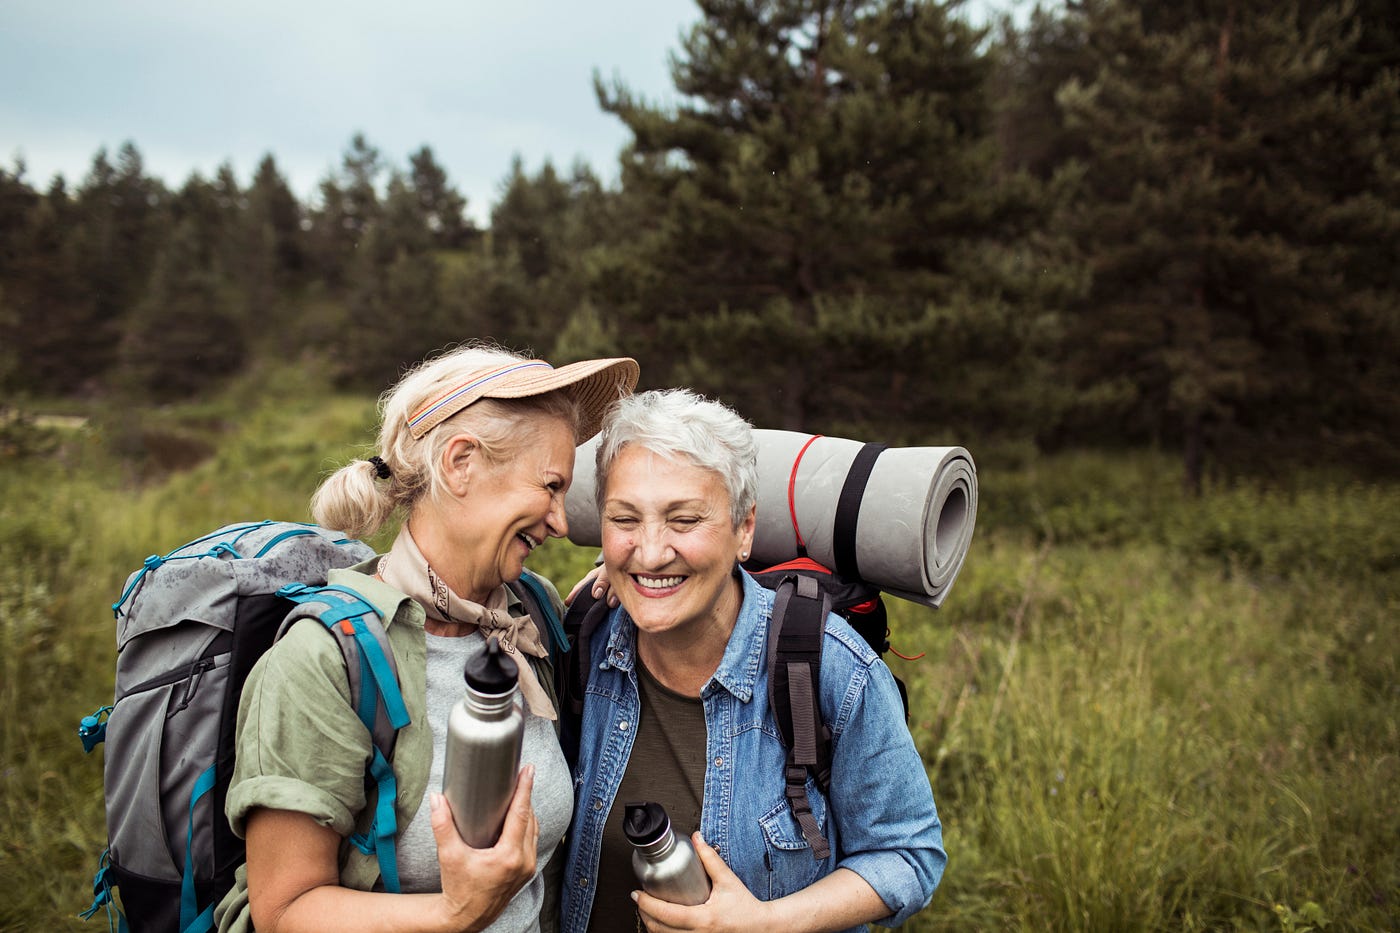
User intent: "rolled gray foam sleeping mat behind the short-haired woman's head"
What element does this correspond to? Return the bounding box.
[566,429,977,608]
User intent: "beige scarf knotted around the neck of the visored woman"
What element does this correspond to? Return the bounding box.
[378,524,559,720]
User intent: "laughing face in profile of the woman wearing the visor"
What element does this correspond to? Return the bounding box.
[450,419,574,602]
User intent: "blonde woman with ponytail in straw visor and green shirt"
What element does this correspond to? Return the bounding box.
[216,345,638,933]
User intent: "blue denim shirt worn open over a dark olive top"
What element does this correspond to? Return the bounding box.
[561,573,948,933]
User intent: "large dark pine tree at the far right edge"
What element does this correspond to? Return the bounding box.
[1060,0,1400,489]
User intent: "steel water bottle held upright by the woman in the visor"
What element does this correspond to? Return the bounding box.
[442,636,525,849]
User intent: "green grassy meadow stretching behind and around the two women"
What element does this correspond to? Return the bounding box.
[0,358,1400,932]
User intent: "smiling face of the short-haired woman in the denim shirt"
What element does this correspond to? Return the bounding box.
[602,445,753,640]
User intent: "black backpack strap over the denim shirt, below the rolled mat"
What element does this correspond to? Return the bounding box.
[769,574,832,859]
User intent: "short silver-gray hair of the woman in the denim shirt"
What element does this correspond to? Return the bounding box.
[596,388,759,528]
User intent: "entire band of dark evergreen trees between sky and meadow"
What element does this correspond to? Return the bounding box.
[0,0,1400,485]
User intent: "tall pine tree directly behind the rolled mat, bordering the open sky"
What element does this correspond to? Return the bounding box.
[595,0,1047,431]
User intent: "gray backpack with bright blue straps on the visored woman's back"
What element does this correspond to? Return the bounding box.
[78,521,409,933]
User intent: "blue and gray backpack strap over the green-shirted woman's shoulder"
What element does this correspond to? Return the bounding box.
[277,583,409,894]
